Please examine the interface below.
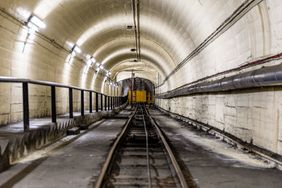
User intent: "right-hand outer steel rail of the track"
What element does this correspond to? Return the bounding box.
[145,109,189,188]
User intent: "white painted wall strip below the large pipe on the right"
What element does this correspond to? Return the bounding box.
[157,88,282,154]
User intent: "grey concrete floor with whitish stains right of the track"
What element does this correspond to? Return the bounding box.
[151,111,282,188]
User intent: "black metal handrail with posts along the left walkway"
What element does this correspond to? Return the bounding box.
[0,76,126,131]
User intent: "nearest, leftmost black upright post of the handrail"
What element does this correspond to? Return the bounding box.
[22,82,29,131]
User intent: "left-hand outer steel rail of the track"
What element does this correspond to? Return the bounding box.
[95,109,137,188]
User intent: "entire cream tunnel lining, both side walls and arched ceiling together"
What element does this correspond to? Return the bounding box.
[0,0,282,154]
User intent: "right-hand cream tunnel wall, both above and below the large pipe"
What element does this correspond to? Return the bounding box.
[157,1,282,154]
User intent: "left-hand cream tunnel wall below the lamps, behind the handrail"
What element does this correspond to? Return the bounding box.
[0,10,120,125]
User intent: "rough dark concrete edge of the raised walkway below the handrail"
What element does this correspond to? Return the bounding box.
[0,104,127,172]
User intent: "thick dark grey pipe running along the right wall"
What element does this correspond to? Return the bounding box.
[156,64,282,99]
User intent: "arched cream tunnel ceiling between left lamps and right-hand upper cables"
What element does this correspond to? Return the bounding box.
[0,0,250,90]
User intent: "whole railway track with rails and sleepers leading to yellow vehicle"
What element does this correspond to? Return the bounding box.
[95,106,188,188]
